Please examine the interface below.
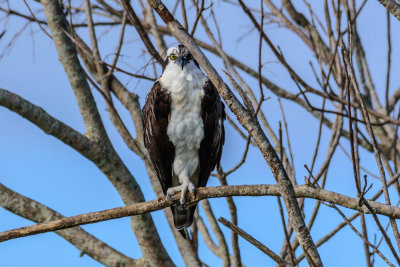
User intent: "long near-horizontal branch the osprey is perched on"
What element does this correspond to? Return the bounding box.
[0,185,400,246]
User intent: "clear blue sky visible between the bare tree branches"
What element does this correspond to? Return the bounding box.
[0,1,400,266]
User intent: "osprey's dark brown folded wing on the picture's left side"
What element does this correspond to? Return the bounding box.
[142,81,175,194]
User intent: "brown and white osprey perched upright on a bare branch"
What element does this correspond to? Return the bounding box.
[143,45,225,237]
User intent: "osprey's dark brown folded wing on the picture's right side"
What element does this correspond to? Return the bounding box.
[198,80,225,187]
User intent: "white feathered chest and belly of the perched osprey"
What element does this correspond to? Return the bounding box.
[160,62,207,178]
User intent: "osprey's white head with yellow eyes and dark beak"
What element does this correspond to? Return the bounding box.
[164,45,199,70]
